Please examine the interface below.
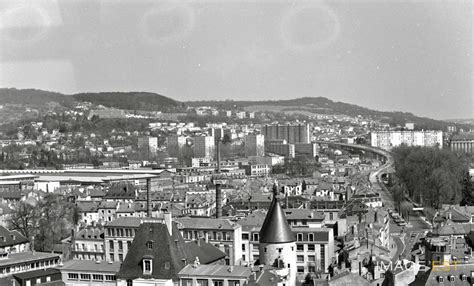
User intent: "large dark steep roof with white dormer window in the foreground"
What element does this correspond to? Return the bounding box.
[118,222,225,279]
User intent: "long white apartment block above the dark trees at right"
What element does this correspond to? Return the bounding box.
[370,130,443,150]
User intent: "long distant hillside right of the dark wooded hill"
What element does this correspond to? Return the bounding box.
[186,97,467,130]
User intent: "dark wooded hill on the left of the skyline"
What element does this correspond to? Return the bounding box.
[0,88,182,111]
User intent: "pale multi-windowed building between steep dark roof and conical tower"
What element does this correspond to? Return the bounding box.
[176,217,242,265]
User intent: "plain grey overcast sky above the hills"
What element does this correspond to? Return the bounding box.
[0,0,474,119]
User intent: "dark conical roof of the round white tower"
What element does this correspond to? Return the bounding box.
[259,197,296,243]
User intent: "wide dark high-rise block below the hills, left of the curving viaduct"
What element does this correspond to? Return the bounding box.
[262,124,311,143]
